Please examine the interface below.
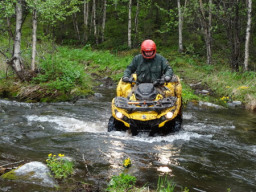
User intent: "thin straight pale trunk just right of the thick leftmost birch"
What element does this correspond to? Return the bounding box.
[31,9,37,71]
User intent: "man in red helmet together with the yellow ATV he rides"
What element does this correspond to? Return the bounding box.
[108,40,182,135]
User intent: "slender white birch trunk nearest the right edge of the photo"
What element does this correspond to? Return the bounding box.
[244,0,252,71]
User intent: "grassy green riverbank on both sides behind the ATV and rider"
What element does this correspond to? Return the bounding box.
[0,46,256,111]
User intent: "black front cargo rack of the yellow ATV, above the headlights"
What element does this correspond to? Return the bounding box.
[115,97,177,113]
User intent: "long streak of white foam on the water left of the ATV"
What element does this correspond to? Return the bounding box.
[26,115,106,132]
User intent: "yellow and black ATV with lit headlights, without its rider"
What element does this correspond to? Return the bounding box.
[108,74,182,136]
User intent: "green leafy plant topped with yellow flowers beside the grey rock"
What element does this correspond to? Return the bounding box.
[46,154,74,179]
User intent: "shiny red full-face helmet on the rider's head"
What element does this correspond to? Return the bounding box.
[141,39,156,59]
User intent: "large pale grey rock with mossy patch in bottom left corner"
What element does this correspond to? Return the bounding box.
[1,161,57,187]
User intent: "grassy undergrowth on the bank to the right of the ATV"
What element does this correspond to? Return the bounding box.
[164,52,256,107]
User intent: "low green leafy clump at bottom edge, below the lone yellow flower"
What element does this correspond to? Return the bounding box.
[107,173,136,192]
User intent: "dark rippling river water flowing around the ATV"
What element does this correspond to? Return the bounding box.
[0,89,256,192]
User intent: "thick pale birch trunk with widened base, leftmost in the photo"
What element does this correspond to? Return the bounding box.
[9,0,25,80]
